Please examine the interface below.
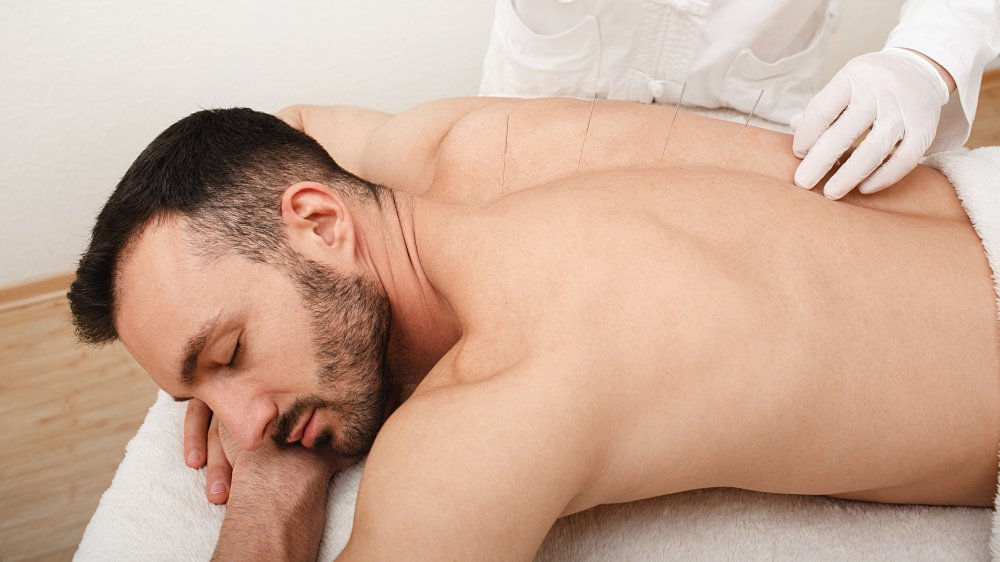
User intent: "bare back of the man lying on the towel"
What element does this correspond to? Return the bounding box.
[406,100,1000,512]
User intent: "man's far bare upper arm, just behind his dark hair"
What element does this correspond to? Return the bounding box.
[277,98,508,193]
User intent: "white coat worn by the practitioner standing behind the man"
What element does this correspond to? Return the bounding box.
[480,0,1000,150]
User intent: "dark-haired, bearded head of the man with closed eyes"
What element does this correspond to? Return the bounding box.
[69,109,390,456]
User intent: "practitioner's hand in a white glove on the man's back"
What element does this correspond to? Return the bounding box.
[791,49,949,199]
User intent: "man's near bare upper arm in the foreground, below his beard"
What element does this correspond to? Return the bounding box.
[338,374,605,560]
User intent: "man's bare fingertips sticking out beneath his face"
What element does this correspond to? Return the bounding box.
[184,398,233,505]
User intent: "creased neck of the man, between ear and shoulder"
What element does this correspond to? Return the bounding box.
[362,189,461,384]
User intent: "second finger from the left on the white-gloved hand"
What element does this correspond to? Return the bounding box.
[795,99,875,189]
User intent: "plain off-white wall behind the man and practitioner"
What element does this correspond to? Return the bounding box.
[0,0,1000,287]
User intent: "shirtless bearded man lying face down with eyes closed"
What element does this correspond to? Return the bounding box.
[70,99,1000,560]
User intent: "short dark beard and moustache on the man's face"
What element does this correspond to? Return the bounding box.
[274,254,391,457]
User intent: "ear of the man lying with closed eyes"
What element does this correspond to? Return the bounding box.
[281,181,356,263]
